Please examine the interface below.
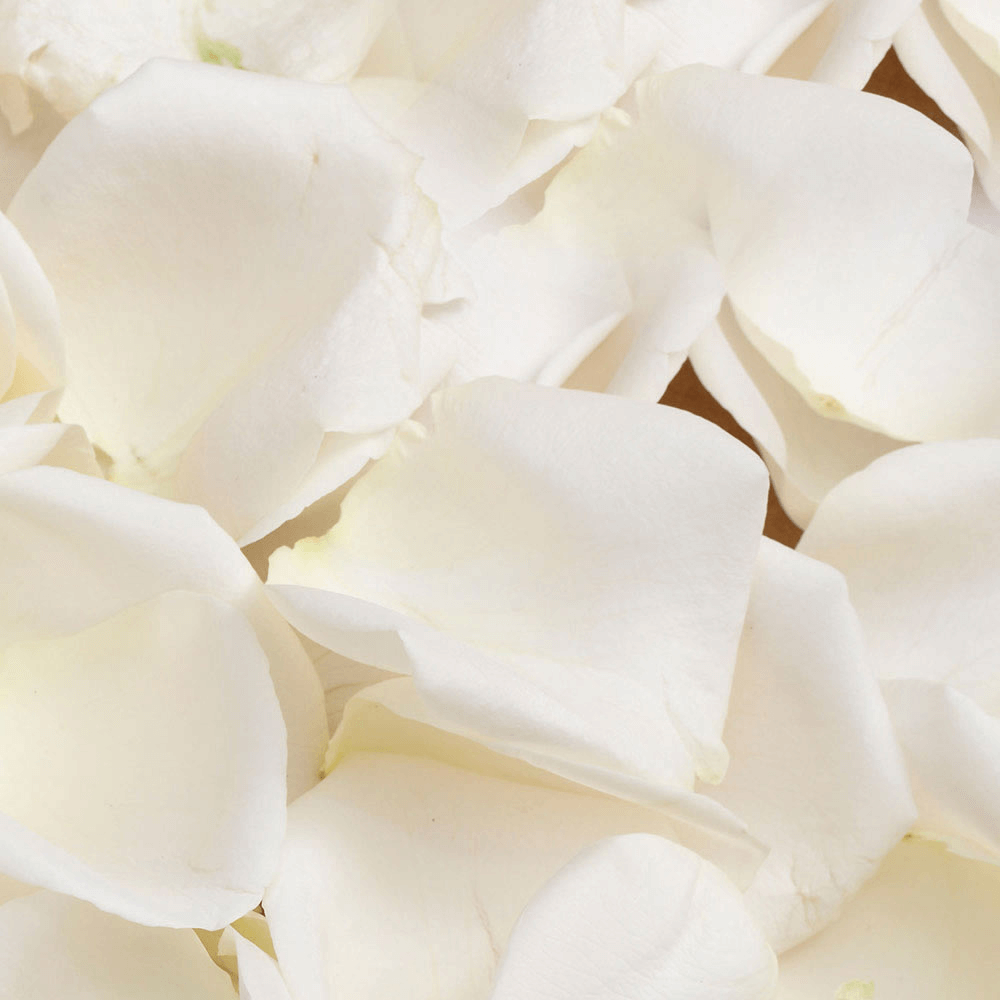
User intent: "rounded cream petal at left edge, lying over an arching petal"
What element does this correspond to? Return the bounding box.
[0,592,286,927]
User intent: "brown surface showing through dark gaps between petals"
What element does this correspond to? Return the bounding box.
[660,49,958,546]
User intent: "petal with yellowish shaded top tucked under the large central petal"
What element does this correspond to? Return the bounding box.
[264,710,766,1000]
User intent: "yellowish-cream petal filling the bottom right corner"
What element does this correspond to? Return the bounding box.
[777,840,1000,1000]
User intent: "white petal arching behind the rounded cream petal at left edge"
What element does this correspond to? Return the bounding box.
[0,468,328,797]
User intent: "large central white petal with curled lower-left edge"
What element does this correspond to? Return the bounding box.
[269,380,766,800]
